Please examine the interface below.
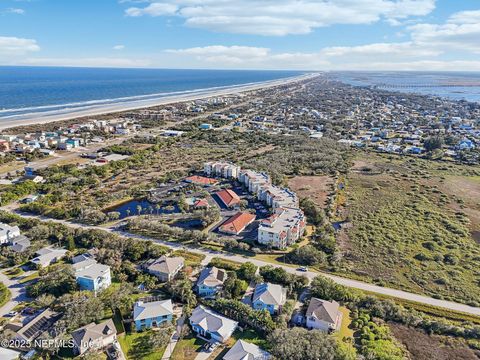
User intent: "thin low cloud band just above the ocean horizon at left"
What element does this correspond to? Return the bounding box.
[21,57,152,68]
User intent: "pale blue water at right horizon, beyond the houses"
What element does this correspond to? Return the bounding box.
[330,71,480,102]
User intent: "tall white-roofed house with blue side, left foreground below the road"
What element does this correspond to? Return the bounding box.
[73,259,112,293]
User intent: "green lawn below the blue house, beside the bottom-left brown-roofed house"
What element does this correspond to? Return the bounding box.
[118,331,165,360]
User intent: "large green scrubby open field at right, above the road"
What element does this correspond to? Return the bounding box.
[339,154,480,305]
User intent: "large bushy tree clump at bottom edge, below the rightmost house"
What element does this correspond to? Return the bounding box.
[268,327,355,360]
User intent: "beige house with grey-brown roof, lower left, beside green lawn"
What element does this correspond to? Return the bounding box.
[72,319,117,355]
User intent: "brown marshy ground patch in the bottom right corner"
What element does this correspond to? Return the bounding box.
[389,324,478,360]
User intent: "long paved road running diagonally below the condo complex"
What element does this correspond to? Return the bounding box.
[5,210,480,316]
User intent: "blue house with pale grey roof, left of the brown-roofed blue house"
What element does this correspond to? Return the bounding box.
[133,299,173,331]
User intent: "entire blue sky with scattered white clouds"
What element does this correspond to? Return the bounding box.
[0,0,480,70]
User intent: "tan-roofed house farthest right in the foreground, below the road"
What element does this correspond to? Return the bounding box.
[305,298,342,331]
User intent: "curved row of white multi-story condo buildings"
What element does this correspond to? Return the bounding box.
[204,162,306,249]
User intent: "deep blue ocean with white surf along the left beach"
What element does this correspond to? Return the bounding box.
[0,66,302,120]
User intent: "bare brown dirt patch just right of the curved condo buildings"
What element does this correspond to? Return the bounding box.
[288,176,334,208]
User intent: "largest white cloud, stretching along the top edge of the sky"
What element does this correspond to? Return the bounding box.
[125,0,435,36]
